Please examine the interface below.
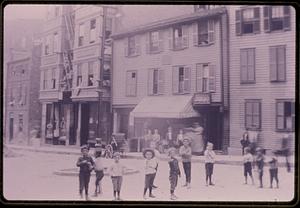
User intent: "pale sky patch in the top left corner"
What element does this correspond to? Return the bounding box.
[4,4,47,20]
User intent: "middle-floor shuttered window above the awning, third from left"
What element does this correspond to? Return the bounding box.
[173,66,191,94]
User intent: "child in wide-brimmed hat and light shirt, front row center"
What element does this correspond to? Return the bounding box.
[143,149,158,199]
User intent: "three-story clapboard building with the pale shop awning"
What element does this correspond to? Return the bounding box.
[112,5,229,150]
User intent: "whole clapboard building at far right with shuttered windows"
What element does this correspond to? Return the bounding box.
[228,5,296,154]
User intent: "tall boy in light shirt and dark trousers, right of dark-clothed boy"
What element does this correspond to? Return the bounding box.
[179,137,192,189]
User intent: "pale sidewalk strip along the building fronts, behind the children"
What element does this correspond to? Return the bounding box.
[5,144,294,167]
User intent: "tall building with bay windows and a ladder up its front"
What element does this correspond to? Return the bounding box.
[40,5,114,146]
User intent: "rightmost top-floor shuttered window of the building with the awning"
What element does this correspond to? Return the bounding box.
[193,20,215,46]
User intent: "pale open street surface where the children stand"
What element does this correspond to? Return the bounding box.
[3,151,294,201]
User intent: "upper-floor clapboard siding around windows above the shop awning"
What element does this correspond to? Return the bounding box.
[113,21,222,105]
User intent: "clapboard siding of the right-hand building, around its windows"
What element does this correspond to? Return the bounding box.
[228,6,295,149]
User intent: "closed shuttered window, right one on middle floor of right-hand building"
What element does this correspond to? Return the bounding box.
[269,46,286,81]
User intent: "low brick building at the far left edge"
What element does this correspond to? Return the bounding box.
[5,44,41,144]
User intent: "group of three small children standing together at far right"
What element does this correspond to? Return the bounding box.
[243,147,279,188]
